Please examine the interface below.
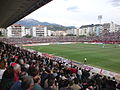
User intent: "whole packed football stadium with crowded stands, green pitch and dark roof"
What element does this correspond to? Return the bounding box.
[0,0,120,90]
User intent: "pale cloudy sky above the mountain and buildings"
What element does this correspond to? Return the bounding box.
[25,0,120,27]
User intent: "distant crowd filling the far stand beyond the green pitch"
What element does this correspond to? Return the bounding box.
[0,32,120,44]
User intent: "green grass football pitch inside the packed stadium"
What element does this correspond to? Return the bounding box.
[26,43,120,73]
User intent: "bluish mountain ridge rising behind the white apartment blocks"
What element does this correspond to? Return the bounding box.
[16,19,75,31]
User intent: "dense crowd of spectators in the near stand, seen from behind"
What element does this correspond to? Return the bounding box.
[0,42,120,90]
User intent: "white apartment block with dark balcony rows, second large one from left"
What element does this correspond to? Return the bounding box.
[32,25,50,37]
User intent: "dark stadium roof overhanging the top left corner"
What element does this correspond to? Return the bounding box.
[0,0,52,28]
